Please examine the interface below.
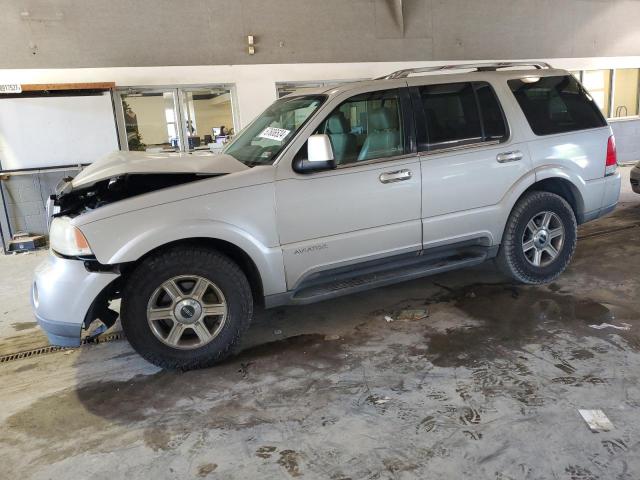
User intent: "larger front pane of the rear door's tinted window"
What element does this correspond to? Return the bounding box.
[419,83,482,149]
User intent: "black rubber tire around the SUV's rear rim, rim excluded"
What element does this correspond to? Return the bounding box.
[496,191,578,285]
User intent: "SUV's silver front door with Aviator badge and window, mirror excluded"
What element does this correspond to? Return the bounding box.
[276,88,422,290]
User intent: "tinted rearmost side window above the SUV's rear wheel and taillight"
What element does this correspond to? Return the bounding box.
[508,75,607,135]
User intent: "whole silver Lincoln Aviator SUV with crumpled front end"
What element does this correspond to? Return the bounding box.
[32,63,620,368]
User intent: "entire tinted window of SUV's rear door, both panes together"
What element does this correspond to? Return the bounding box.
[418,82,507,150]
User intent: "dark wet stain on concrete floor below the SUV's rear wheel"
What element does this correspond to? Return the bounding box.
[425,285,634,368]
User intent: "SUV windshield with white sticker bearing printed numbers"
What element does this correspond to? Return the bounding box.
[222,95,326,167]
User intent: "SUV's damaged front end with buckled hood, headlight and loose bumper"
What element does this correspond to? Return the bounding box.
[31,151,249,347]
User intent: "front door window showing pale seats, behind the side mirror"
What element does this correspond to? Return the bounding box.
[315,90,404,165]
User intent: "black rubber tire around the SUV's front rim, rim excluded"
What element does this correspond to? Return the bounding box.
[121,246,253,370]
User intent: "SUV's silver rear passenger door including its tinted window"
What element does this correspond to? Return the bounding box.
[411,82,531,248]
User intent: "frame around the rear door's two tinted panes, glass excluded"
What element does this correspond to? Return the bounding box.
[409,80,511,155]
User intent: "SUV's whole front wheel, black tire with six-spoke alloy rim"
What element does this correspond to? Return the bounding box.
[121,247,253,369]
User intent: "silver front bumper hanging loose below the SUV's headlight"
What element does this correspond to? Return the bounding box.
[31,253,119,347]
